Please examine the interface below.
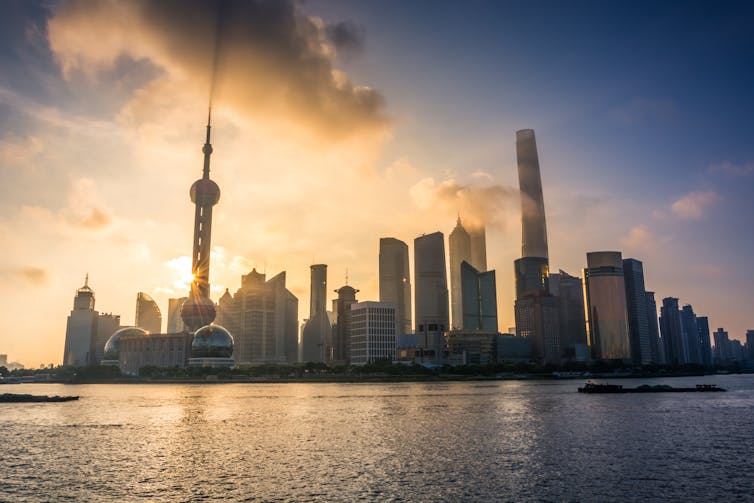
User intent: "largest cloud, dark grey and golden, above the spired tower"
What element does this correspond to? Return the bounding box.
[48,0,389,138]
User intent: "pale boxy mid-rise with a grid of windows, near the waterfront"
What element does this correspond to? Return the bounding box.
[349,301,396,365]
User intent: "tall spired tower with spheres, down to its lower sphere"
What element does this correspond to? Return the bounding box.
[181,111,220,332]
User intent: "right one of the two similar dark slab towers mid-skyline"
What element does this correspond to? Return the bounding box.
[414,232,449,334]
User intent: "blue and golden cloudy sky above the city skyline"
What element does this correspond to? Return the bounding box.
[0,0,754,366]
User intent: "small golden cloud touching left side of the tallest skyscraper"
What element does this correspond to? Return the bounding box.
[409,177,519,228]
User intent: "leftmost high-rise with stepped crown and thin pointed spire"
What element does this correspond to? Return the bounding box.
[63,274,98,367]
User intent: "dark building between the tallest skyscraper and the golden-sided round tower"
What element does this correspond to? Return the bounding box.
[550,270,589,361]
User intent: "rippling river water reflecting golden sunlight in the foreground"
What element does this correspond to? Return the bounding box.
[0,375,754,502]
